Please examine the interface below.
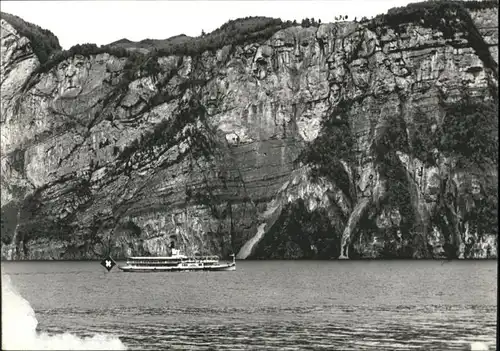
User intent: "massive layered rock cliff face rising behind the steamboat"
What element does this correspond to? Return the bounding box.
[1,3,498,259]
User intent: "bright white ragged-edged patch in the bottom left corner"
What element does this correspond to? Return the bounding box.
[2,274,127,350]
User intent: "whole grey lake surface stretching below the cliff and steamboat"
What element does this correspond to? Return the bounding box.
[2,261,497,350]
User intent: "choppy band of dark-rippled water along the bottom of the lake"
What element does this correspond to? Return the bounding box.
[37,305,496,350]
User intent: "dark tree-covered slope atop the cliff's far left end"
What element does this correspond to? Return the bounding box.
[0,12,61,64]
